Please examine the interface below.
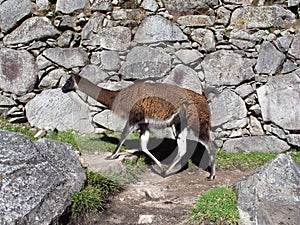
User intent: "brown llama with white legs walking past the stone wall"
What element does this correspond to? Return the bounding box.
[62,74,216,180]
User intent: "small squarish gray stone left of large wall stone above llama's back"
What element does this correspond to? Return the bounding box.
[100,51,121,70]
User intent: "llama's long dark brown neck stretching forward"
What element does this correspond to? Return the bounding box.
[74,75,119,109]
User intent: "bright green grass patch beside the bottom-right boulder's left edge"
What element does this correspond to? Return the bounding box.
[191,187,239,224]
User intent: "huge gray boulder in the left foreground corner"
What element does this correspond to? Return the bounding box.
[0,131,85,225]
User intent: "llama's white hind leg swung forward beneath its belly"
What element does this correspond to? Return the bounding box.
[165,127,188,175]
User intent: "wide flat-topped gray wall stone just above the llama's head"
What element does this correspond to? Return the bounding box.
[43,48,89,69]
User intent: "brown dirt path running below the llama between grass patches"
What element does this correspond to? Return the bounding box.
[72,152,249,225]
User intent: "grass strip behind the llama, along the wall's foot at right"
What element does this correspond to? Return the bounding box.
[217,150,278,170]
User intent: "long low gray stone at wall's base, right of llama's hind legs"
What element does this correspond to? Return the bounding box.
[223,136,290,152]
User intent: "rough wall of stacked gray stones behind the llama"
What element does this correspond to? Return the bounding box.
[0,0,300,152]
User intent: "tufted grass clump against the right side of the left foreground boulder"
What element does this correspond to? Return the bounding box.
[72,170,122,216]
